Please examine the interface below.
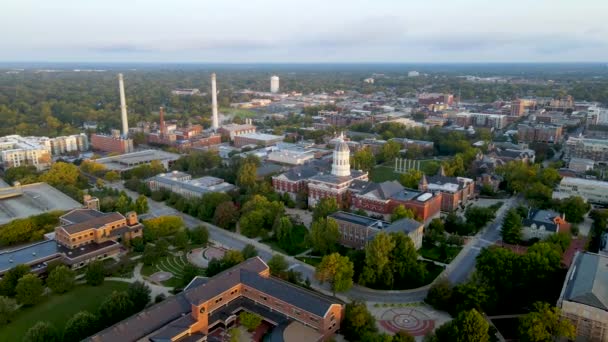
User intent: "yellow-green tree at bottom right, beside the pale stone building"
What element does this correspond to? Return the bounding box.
[519,302,576,342]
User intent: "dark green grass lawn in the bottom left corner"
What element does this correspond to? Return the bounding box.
[0,281,129,341]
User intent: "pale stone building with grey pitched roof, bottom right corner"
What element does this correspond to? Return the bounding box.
[557,252,608,342]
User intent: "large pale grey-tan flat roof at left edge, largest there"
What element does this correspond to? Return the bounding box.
[0,183,82,224]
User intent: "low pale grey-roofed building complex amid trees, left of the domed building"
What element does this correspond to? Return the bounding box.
[147,171,236,199]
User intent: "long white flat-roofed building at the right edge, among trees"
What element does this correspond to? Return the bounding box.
[553,177,608,204]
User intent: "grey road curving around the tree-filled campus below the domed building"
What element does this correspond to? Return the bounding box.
[106,183,521,303]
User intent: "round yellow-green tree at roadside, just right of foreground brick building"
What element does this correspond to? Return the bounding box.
[315,253,355,296]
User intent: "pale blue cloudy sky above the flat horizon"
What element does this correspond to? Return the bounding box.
[0,0,608,63]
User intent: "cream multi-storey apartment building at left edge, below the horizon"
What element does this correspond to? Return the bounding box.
[0,135,52,171]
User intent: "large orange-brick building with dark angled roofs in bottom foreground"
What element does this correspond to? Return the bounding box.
[88,257,344,342]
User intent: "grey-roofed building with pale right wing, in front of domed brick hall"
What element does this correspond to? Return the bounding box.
[329,211,424,249]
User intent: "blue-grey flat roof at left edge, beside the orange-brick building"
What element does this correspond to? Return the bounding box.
[0,240,59,273]
